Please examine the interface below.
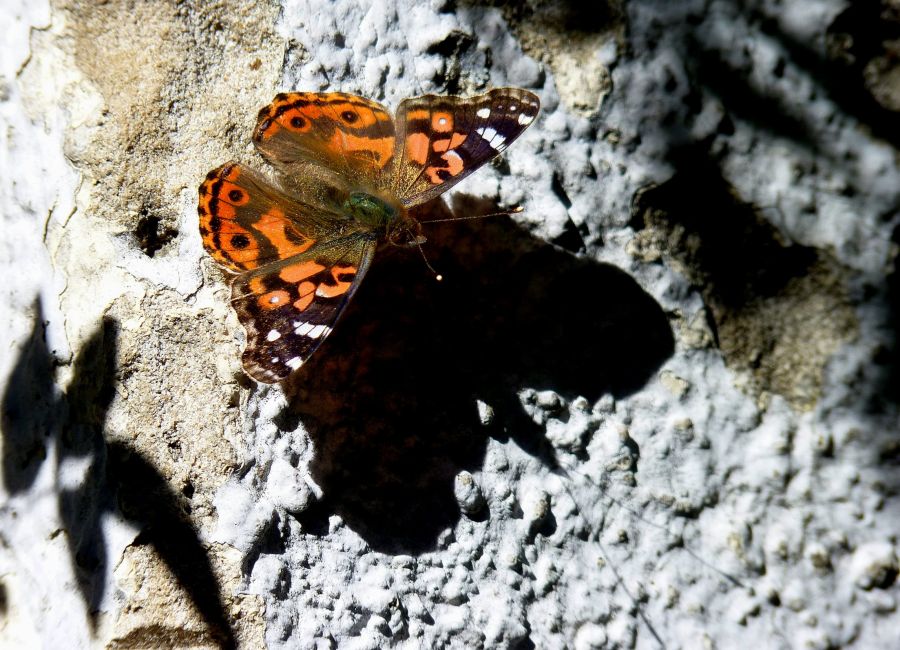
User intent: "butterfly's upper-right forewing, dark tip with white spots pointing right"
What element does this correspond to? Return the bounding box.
[392,88,540,207]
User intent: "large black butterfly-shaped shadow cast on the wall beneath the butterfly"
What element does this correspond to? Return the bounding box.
[282,205,674,553]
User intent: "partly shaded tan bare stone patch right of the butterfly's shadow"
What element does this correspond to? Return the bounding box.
[629,175,857,410]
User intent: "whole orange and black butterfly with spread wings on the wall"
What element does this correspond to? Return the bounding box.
[197,88,540,383]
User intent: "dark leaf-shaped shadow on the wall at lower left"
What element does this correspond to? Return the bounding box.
[0,301,236,648]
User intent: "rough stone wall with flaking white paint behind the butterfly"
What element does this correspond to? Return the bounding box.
[0,0,900,648]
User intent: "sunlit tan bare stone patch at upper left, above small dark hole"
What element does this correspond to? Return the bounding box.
[56,1,283,243]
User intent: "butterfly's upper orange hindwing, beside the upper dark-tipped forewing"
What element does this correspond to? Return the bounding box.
[253,93,395,187]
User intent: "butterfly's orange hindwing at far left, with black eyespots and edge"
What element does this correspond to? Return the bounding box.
[197,162,340,272]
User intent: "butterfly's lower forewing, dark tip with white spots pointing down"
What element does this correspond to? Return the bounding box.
[231,233,376,384]
